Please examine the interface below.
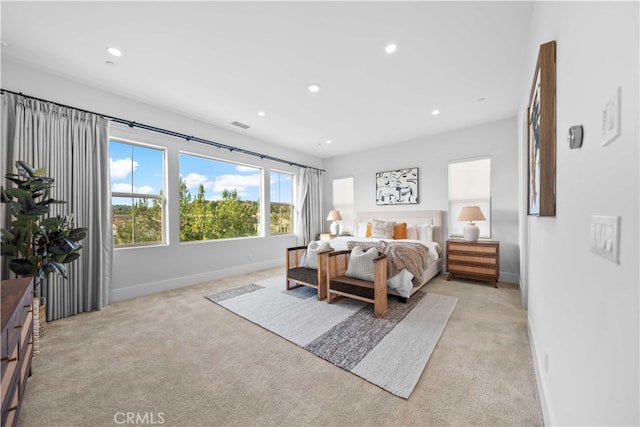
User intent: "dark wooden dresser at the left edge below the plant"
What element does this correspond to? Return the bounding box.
[0,277,33,426]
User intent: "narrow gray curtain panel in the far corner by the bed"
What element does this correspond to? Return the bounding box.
[294,168,324,245]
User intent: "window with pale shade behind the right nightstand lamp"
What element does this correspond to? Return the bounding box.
[449,158,491,238]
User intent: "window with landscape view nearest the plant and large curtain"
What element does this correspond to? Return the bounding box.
[109,139,165,247]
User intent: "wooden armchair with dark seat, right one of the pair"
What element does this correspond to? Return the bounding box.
[326,251,387,317]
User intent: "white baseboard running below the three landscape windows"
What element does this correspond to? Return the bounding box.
[110,259,284,302]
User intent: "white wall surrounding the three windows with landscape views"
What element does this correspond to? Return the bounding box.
[2,61,322,301]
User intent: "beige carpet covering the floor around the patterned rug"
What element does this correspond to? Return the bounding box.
[18,266,542,427]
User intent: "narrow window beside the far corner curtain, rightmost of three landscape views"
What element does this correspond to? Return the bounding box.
[269,171,293,235]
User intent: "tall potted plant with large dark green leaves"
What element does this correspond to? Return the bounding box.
[1,160,87,334]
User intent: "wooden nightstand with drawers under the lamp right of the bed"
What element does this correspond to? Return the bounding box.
[447,239,500,288]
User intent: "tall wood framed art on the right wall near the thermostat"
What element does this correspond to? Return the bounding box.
[527,41,556,216]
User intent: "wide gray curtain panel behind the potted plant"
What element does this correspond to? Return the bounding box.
[2,93,113,320]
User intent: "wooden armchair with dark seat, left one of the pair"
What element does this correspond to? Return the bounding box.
[285,246,334,300]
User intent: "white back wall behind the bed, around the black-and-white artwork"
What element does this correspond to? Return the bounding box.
[325,117,520,283]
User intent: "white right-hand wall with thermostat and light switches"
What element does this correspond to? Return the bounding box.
[519,2,640,426]
